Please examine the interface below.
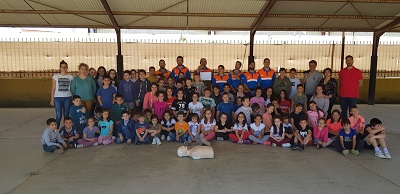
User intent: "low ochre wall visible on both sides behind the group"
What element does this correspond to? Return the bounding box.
[0,78,400,107]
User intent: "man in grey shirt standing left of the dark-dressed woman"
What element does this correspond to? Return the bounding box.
[302,60,323,100]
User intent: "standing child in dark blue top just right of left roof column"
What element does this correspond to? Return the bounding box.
[118,70,136,111]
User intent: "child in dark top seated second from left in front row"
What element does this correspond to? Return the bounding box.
[60,117,82,148]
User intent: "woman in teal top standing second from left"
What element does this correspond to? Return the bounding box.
[71,63,97,115]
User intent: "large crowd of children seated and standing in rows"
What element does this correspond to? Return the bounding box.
[42,66,391,158]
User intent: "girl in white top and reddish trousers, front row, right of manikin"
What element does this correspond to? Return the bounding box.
[229,112,251,144]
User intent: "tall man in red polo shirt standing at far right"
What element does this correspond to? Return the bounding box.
[339,55,363,118]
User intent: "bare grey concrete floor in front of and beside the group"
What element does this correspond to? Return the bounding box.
[0,105,400,194]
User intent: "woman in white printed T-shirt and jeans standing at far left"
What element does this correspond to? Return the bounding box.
[50,60,74,128]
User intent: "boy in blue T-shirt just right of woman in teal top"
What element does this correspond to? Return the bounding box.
[96,75,117,109]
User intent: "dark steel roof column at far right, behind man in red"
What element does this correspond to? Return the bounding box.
[368,32,382,105]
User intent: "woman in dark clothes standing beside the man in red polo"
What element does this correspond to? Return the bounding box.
[319,68,338,118]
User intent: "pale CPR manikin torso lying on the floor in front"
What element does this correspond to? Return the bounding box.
[177,146,214,160]
